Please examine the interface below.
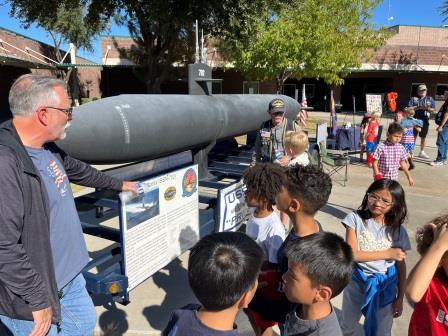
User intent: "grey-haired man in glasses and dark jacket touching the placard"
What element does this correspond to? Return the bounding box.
[0,75,137,336]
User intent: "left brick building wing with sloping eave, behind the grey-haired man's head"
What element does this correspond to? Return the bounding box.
[0,27,101,121]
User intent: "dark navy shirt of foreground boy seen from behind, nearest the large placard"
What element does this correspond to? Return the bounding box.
[162,304,238,336]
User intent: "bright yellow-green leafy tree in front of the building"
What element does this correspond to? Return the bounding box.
[228,0,387,91]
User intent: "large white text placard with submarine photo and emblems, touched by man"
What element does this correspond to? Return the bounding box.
[120,165,199,291]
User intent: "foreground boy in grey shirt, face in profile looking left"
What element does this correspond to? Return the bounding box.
[283,232,354,336]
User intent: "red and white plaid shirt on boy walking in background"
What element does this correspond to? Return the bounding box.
[373,140,408,180]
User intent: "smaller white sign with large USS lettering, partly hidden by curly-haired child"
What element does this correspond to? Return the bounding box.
[218,181,250,232]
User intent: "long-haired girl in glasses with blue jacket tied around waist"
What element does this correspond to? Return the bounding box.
[341,179,411,336]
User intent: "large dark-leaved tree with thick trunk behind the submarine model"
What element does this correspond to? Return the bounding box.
[103,0,284,93]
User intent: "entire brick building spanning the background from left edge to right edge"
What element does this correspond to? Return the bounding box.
[0,25,448,119]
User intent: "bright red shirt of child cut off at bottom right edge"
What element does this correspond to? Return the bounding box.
[408,268,448,336]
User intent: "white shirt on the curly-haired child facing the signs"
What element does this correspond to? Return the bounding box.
[246,208,286,264]
